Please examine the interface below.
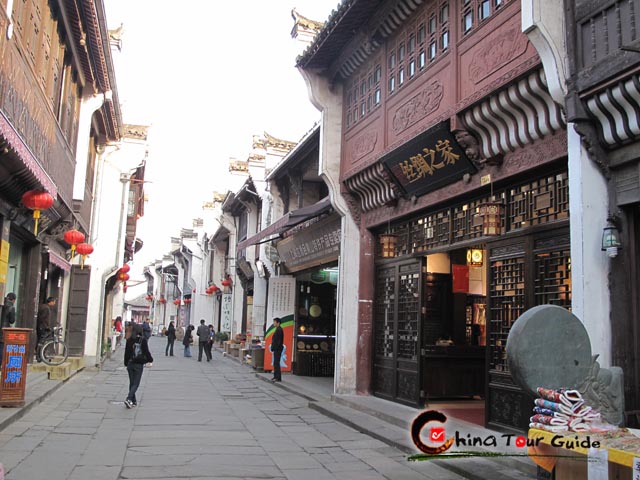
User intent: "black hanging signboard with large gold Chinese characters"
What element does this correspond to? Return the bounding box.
[380,122,476,196]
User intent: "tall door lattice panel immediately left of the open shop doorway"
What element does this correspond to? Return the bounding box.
[398,272,420,361]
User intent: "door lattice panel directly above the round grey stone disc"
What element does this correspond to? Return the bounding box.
[534,248,571,310]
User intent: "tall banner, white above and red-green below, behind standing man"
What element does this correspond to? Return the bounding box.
[264,276,296,372]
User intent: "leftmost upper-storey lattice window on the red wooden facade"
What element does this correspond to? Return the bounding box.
[344,58,382,128]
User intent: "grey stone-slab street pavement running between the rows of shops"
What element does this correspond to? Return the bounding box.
[0,337,462,480]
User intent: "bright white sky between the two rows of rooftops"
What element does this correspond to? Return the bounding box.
[105,0,339,267]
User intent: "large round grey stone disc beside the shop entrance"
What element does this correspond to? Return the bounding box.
[507,305,592,395]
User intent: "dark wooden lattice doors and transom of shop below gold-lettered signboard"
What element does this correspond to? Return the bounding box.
[372,167,571,430]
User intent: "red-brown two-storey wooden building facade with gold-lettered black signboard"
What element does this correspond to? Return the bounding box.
[298,0,571,430]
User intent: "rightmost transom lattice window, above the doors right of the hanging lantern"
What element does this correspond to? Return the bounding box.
[507,172,569,231]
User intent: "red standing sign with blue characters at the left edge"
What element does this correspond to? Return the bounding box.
[0,328,31,407]
